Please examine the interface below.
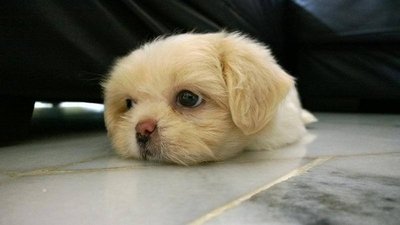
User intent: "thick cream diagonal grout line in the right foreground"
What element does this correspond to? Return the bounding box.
[189,156,334,225]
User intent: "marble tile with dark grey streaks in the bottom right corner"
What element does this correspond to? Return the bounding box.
[207,154,400,224]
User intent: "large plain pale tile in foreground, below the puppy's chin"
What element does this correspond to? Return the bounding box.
[0,156,309,225]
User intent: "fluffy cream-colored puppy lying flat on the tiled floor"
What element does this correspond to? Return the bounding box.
[103,32,315,165]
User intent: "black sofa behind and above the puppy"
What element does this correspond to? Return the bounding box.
[0,0,400,140]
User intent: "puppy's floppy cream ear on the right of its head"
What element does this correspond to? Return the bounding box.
[220,33,294,135]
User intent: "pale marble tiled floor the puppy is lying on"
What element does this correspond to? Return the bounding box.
[0,106,400,225]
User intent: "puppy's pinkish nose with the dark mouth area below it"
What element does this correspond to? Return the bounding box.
[135,119,157,159]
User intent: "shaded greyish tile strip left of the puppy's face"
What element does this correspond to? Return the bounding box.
[0,131,111,171]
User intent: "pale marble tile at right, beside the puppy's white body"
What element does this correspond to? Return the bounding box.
[223,114,400,160]
